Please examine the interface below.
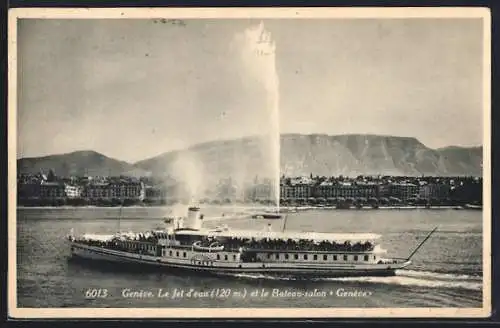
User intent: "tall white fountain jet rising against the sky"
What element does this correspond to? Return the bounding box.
[235,22,280,209]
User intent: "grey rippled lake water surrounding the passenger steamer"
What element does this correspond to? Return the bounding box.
[17,207,483,308]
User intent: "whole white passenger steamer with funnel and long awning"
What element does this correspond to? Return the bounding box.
[68,207,432,277]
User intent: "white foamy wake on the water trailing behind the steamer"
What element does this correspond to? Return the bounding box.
[221,270,483,291]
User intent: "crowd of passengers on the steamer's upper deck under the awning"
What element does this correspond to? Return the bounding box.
[197,237,374,252]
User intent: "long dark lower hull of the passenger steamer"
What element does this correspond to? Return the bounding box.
[71,244,410,278]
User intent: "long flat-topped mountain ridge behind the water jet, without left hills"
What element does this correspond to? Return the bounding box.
[135,134,482,176]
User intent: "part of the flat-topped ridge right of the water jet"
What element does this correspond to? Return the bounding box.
[281,135,482,176]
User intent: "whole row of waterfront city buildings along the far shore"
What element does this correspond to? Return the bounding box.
[17,173,482,204]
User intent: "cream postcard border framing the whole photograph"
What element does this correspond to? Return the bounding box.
[7,7,492,319]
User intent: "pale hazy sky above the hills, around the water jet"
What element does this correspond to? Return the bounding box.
[17,18,483,162]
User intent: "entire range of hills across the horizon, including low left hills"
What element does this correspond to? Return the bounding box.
[17,134,482,179]
